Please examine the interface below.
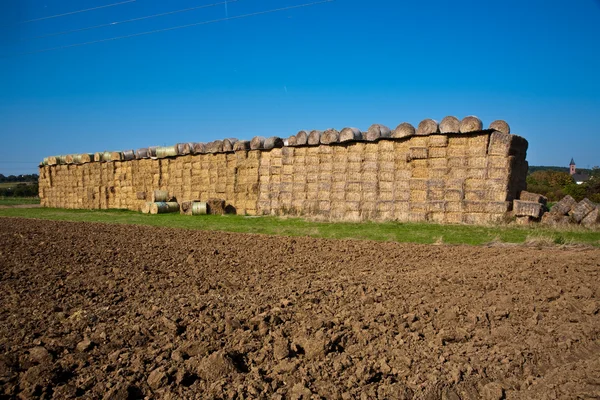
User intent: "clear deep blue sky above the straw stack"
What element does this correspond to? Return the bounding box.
[0,0,600,175]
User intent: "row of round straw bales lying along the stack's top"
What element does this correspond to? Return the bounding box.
[42,116,510,165]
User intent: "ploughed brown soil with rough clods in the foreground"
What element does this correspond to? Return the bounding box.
[0,218,600,399]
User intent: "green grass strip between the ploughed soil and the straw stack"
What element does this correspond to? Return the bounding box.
[0,208,600,247]
